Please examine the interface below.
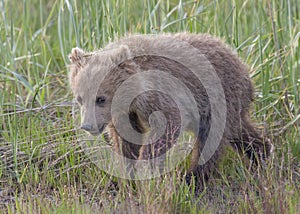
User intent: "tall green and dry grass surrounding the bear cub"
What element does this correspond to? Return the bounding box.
[0,0,300,213]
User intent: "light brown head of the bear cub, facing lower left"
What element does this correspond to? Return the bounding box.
[69,45,135,135]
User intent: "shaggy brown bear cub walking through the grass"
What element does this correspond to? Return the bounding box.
[69,33,272,183]
